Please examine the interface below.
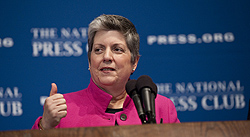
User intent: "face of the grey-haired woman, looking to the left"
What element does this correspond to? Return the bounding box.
[89,30,138,89]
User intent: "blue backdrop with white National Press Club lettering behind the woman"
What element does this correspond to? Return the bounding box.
[0,0,250,131]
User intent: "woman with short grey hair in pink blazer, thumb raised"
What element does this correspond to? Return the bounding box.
[32,15,179,130]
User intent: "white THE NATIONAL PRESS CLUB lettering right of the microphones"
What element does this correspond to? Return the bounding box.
[156,80,246,111]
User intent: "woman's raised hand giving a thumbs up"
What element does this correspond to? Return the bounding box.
[41,83,67,129]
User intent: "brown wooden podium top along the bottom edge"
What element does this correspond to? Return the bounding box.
[0,121,250,137]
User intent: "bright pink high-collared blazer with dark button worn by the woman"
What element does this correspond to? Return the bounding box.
[32,79,180,129]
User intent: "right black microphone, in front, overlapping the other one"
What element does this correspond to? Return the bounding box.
[136,75,157,123]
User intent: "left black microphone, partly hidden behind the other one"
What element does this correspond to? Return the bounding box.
[125,79,146,124]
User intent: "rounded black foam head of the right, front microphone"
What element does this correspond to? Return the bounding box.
[136,75,157,95]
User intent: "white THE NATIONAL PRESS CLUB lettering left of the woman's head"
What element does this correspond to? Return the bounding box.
[30,28,87,57]
